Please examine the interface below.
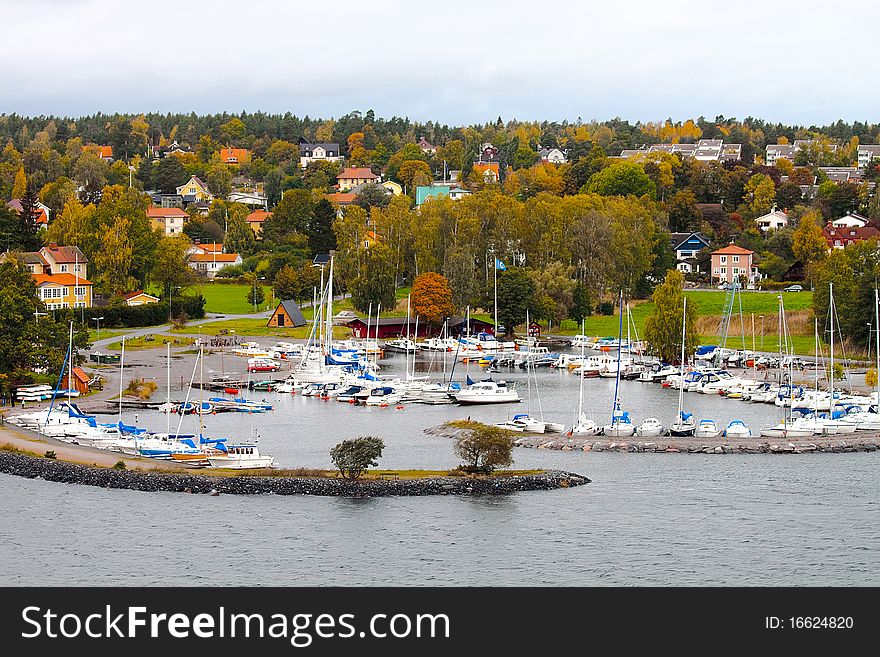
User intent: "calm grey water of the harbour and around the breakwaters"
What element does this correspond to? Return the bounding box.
[0,348,880,586]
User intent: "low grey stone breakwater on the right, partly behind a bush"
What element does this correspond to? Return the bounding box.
[425,424,880,454]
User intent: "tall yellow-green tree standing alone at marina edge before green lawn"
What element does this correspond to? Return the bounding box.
[645,269,698,363]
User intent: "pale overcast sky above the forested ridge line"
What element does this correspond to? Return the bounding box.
[0,0,880,124]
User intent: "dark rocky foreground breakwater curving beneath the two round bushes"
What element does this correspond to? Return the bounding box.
[0,451,590,497]
